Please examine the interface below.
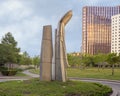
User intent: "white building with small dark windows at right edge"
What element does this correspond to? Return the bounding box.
[111,14,120,54]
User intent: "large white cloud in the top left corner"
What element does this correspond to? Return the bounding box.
[0,0,32,21]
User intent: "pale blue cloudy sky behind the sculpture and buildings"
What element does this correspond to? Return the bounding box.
[0,0,120,56]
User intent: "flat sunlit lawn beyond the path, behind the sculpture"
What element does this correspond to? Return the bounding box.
[30,68,120,80]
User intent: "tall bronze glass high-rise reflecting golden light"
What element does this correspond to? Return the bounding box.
[82,6,120,54]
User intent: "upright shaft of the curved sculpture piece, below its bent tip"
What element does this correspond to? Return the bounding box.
[55,24,66,82]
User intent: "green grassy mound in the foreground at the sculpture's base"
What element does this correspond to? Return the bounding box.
[0,79,112,96]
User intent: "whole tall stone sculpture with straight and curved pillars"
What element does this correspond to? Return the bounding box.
[40,10,72,82]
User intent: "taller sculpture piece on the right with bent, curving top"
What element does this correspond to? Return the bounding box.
[55,10,72,82]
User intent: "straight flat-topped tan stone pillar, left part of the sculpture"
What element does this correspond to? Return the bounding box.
[40,25,53,81]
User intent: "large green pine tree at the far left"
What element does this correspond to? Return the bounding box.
[0,32,20,66]
